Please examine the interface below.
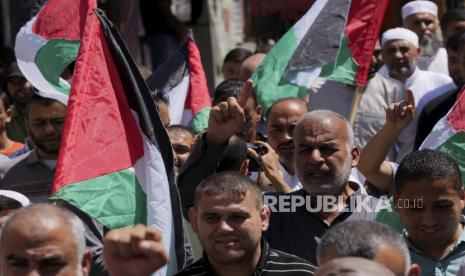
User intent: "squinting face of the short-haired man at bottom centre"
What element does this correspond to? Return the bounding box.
[189,192,270,265]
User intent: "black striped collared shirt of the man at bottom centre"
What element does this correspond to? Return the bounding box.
[176,239,316,276]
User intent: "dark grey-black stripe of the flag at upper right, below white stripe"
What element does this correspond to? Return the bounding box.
[286,0,351,71]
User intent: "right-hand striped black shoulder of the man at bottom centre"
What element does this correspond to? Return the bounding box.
[265,249,317,275]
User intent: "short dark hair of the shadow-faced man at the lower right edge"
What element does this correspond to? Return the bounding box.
[394,149,462,193]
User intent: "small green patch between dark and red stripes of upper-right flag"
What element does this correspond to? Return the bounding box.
[320,34,358,85]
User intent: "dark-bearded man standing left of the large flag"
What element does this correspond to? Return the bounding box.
[0,94,66,203]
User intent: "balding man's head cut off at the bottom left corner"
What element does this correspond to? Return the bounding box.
[0,204,92,276]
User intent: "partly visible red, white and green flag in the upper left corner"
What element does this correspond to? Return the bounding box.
[15,0,85,104]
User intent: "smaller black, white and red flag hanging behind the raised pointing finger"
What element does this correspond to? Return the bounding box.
[147,32,211,125]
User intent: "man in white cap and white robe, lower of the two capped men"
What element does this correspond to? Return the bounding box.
[381,28,455,161]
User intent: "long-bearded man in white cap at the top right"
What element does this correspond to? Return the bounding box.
[402,0,449,75]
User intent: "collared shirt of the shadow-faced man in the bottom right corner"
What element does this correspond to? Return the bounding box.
[402,221,465,276]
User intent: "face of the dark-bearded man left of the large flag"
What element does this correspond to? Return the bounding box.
[27,101,66,159]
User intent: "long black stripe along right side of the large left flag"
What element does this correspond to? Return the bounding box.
[95,9,187,269]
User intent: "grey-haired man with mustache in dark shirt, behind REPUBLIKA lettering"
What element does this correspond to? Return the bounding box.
[265,110,383,264]
